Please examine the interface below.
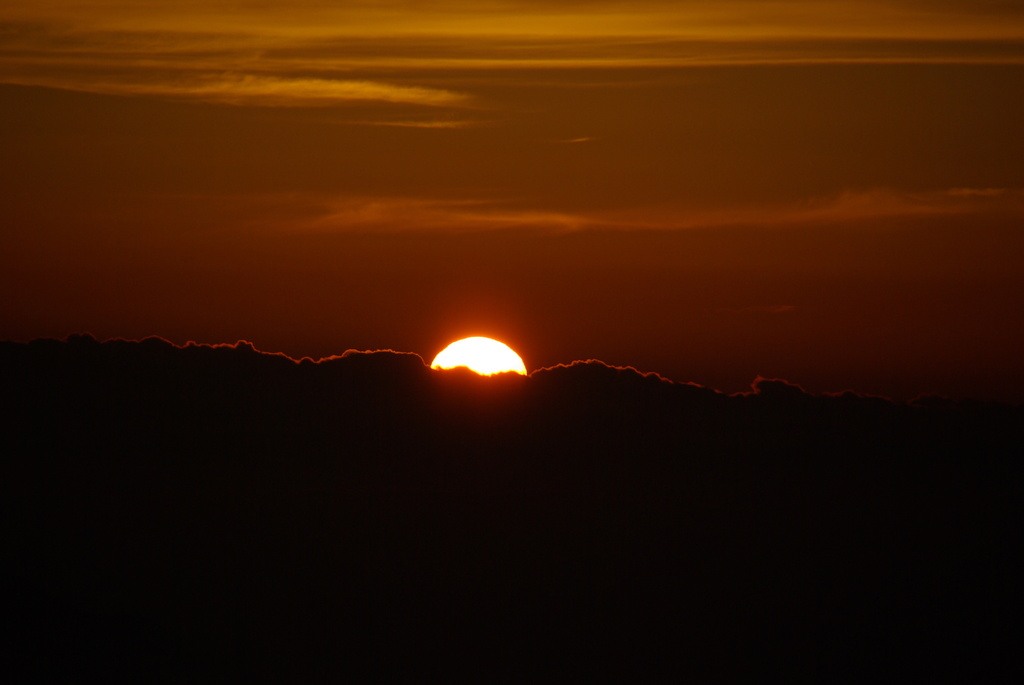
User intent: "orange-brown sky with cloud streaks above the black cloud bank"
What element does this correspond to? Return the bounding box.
[0,0,1024,401]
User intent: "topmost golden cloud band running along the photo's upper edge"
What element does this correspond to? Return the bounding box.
[4,0,1024,38]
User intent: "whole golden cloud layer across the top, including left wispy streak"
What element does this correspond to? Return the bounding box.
[0,0,1024,104]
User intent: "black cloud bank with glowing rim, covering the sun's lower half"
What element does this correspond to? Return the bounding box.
[0,337,1024,683]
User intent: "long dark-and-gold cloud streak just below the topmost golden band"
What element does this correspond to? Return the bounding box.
[0,23,1024,74]
